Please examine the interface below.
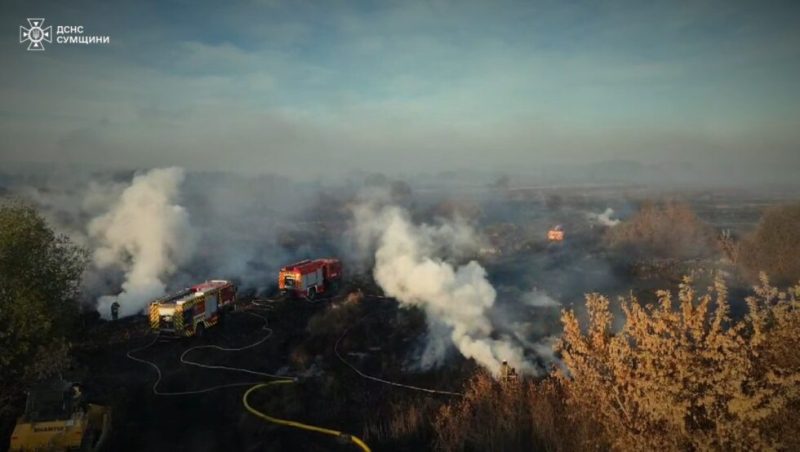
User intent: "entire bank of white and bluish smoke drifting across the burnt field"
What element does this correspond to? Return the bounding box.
[5,164,636,373]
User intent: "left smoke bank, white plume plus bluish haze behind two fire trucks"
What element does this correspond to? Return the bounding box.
[0,168,346,317]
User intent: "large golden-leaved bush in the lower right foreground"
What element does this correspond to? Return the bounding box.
[559,276,800,450]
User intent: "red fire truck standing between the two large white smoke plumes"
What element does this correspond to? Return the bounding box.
[278,259,342,299]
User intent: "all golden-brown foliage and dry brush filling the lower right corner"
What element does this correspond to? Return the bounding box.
[435,276,800,450]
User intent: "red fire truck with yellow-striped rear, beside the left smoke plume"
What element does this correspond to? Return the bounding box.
[150,280,236,336]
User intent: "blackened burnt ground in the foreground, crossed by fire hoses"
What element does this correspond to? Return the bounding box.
[74,292,474,451]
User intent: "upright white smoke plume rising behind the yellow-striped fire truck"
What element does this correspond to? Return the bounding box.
[88,168,195,317]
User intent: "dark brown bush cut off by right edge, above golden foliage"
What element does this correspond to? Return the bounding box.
[739,204,800,284]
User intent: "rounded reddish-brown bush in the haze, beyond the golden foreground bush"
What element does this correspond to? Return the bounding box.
[606,202,715,259]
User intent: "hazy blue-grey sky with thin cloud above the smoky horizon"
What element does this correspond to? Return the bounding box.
[0,0,800,181]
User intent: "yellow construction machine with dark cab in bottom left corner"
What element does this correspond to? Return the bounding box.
[9,381,111,452]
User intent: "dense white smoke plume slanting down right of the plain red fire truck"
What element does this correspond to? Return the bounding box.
[354,202,535,374]
